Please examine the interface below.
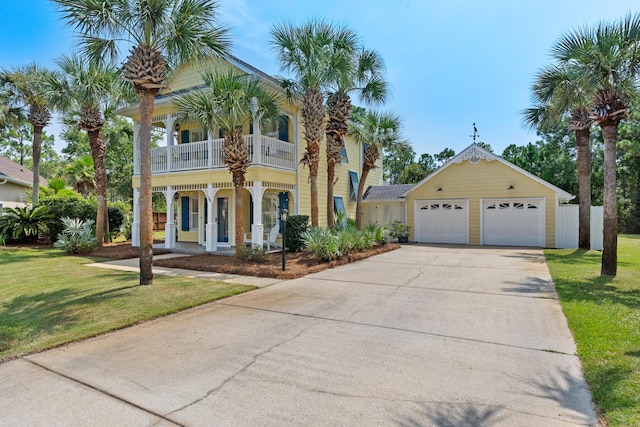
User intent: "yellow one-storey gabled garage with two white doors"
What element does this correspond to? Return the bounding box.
[364,144,602,247]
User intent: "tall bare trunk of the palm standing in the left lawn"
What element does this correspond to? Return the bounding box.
[138,89,157,285]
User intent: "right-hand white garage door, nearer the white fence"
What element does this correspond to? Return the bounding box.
[482,199,545,246]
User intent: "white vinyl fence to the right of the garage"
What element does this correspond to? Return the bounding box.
[556,205,603,251]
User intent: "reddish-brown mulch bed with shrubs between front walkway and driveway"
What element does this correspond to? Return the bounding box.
[153,243,400,279]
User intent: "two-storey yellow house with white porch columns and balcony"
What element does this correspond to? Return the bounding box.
[118,57,382,252]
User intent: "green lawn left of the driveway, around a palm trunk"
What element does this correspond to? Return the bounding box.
[0,249,254,361]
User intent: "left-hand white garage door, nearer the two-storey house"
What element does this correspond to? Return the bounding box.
[414,200,468,244]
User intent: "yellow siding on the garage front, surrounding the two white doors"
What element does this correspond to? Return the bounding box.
[407,160,556,247]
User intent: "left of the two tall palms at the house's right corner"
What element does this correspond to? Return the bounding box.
[270,20,356,227]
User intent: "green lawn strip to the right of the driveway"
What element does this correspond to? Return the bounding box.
[545,235,640,426]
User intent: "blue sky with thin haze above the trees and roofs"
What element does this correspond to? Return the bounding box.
[0,0,638,155]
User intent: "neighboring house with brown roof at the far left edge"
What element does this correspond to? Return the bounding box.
[0,155,47,208]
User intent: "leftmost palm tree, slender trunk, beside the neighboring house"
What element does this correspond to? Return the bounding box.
[0,63,51,204]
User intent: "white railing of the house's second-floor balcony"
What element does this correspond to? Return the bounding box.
[146,135,297,173]
